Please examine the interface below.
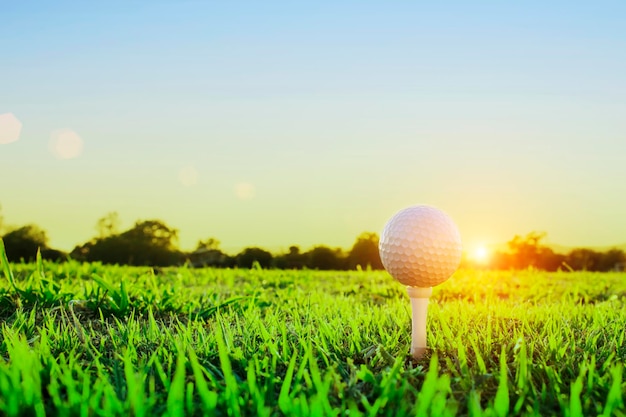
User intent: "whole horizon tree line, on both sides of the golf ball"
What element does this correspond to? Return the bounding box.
[0,212,626,272]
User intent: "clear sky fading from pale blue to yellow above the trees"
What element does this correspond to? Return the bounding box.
[0,0,626,252]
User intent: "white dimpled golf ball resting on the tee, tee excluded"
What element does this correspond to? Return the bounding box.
[378,205,461,287]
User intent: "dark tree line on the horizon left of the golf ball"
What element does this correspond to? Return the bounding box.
[2,212,383,270]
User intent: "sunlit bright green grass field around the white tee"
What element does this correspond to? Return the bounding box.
[0,239,626,417]
